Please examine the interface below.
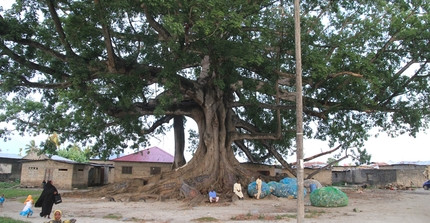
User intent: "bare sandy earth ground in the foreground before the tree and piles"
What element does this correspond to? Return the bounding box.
[0,188,430,223]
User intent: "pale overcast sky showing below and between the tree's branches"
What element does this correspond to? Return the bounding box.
[0,0,430,162]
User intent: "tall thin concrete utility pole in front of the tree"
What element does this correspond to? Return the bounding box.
[294,0,305,223]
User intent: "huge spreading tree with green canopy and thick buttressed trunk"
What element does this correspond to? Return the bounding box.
[0,0,430,195]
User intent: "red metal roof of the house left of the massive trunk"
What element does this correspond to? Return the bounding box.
[112,146,173,163]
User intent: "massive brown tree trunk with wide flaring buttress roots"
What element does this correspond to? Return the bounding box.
[147,86,251,197]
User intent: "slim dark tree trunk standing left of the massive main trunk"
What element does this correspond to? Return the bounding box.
[172,115,186,169]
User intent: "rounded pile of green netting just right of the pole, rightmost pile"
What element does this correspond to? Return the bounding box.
[310,187,348,207]
